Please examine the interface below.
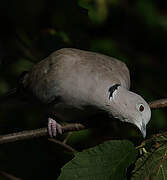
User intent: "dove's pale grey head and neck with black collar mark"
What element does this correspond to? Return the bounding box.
[108,84,151,138]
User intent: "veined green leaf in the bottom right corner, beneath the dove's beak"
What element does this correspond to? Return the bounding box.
[132,136,167,180]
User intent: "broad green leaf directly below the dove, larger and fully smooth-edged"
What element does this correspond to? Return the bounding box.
[58,140,136,180]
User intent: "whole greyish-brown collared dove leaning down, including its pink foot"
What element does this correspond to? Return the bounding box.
[22,48,151,137]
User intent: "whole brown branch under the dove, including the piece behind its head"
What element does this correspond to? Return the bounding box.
[0,98,167,144]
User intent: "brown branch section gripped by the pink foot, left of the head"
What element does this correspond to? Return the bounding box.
[0,124,85,144]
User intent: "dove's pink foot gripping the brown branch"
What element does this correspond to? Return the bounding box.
[48,118,62,137]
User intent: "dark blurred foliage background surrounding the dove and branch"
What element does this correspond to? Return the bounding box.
[0,0,167,180]
